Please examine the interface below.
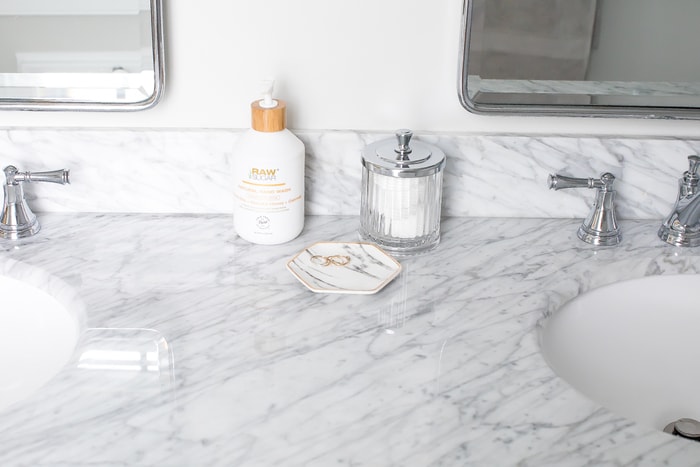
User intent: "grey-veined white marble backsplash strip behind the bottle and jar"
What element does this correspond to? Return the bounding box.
[0,128,700,219]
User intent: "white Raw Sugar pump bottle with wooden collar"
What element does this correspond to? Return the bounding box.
[233,82,305,245]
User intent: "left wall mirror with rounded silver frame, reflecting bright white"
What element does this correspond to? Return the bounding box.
[0,0,165,111]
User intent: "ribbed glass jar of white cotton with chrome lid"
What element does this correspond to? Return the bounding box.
[360,130,445,255]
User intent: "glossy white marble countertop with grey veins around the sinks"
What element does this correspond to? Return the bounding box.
[0,214,700,466]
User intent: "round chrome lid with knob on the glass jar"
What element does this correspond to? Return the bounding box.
[362,130,445,178]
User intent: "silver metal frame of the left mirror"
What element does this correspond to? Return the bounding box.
[0,0,165,112]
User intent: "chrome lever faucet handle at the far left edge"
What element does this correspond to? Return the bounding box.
[0,165,70,240]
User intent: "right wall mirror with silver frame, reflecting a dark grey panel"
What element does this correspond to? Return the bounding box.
[459,0,700,118]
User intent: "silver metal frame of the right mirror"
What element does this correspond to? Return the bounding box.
[458,0,700,120]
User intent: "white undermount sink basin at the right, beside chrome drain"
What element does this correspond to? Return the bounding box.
[540,275,700,429]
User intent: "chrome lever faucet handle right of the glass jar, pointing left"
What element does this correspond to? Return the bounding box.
[547,173,622,246]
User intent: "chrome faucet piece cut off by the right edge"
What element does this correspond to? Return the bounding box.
[659,156,700,246]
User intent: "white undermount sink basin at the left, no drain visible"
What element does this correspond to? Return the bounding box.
[0,274,80,410]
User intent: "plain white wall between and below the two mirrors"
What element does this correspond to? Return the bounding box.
[0,0,700,136]
